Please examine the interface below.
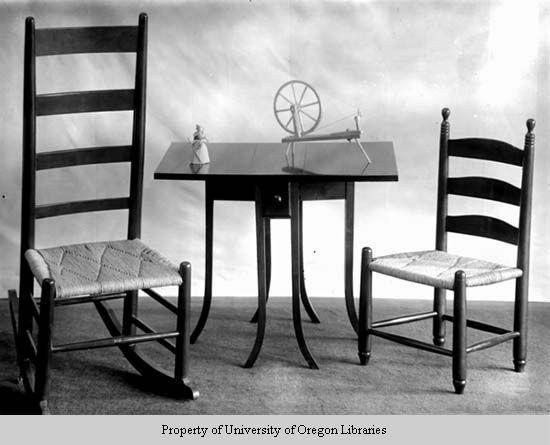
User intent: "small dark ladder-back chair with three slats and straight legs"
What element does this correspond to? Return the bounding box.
[358,108,535,394]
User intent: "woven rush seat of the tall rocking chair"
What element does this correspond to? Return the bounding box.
[25,239,182,298]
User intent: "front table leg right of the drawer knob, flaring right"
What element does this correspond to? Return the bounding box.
[290,183,319,369]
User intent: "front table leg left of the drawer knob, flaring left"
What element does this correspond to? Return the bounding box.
[244,187,269,368]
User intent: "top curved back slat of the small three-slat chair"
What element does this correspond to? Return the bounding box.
[448,138,523,166]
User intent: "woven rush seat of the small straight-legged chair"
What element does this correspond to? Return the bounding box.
[369,250,522,290]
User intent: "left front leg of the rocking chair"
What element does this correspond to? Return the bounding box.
[34,279,55,414]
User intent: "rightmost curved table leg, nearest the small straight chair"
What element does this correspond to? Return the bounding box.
[344,182,359,332]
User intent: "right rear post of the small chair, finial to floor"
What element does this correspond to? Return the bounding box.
[513,119,535,372]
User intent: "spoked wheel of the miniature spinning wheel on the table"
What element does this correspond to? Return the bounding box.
[273,80,322,136]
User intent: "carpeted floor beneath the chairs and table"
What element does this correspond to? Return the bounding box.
[0,298,550,414]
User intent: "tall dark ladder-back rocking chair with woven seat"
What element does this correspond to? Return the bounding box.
[9,14,198,413]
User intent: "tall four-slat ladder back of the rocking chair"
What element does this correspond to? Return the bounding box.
[20,13,147,270]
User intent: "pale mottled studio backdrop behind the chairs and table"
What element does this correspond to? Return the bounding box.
[0,0,550,301]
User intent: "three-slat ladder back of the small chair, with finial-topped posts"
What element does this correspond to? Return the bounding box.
[436,108,535,260]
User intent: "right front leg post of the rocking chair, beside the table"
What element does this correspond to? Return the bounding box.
[179,261,191,380]
